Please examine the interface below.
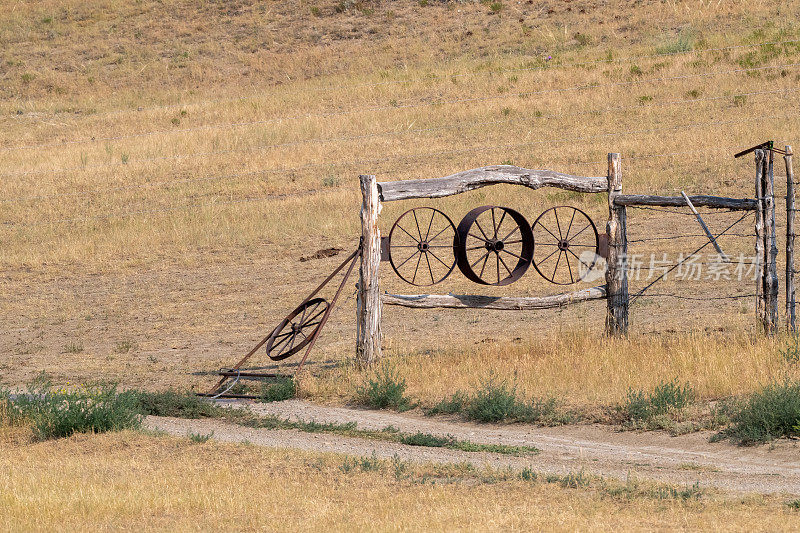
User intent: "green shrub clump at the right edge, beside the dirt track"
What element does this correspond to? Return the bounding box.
[717,380,800,444]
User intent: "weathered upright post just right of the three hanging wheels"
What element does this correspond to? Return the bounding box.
[606,154,628,336]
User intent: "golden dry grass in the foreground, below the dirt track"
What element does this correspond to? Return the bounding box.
[0,432,797,531]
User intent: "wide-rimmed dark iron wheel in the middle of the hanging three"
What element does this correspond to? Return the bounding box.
[453,205,533,285]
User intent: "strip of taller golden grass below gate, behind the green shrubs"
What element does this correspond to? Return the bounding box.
[300,332,800,408]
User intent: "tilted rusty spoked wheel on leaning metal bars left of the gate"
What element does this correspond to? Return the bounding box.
[267,298,330,361]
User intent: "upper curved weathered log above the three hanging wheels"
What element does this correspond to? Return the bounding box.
[378,165,608,202]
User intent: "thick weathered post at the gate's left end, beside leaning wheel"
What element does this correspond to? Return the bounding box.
[356,175,381,367]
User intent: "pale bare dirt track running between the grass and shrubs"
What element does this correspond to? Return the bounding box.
[145,400,800,495]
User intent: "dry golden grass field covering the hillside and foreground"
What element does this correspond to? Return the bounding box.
[0,0,800,530]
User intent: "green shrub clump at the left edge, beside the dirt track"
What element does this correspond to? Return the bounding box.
[0,378,141,440]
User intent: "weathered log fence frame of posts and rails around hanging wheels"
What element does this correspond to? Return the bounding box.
[356,149,795,365]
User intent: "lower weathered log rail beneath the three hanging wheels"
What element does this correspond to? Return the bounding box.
[381,285,606,311]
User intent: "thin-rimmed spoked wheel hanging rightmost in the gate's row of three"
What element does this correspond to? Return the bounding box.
[531,205,599,285]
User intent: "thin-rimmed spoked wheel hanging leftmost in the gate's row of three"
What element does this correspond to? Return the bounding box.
[388,207,456,286]
